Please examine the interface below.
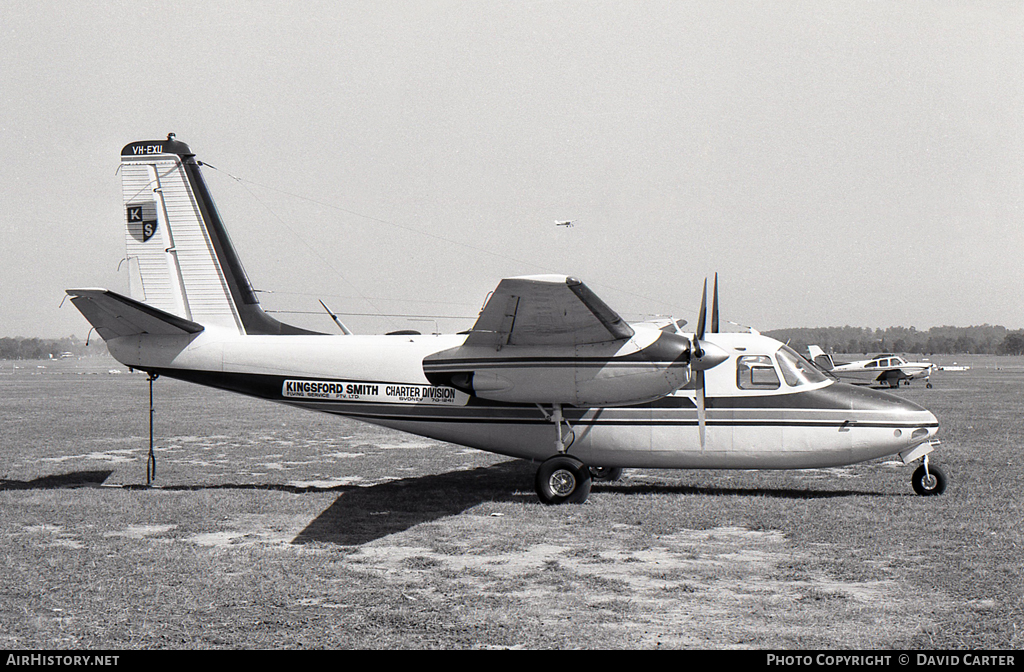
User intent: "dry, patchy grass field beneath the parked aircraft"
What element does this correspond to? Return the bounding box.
[0,356,1024,649]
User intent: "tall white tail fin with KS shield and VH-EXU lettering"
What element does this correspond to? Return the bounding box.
[115,133,316,334]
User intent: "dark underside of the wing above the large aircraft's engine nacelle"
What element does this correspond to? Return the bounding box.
[466,276,634,349]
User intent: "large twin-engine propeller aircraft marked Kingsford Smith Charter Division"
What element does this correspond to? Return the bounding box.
[61,135,946,503]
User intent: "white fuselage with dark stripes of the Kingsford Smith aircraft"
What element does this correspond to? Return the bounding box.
[108,328,938,469]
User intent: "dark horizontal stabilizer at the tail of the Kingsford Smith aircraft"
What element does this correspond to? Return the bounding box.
[67,289,203,340]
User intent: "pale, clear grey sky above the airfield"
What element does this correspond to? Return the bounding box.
[0,0,1024,338]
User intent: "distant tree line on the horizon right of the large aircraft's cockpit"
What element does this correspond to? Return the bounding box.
[765,325,1024,354]
